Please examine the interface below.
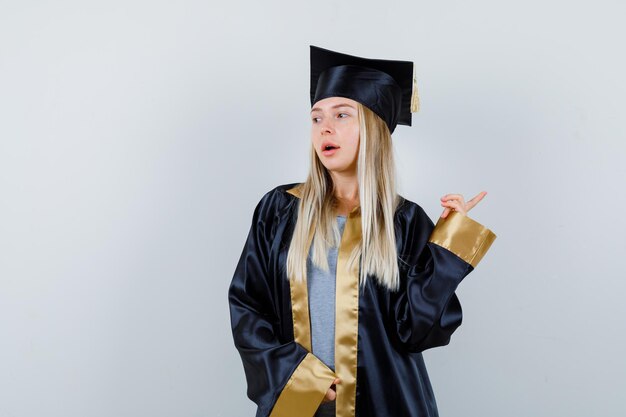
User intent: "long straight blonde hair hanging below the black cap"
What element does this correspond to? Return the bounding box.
[287,103,400,291]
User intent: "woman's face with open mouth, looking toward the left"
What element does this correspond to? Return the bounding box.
[311,97,359,175]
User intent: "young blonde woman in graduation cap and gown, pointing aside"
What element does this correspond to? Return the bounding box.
[228,46,495,417]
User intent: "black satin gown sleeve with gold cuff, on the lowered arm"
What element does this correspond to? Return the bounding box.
[228,190,336,417]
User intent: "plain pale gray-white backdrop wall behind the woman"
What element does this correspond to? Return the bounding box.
[0,0,626,417]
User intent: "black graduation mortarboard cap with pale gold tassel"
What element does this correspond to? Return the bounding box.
[310,45,419,132]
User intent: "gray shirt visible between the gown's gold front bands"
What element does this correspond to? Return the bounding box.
[307,216,346,417]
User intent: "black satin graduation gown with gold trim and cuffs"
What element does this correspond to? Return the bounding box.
[228,183,495,417]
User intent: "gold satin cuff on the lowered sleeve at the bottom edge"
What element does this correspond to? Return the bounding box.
[270,352,336,417]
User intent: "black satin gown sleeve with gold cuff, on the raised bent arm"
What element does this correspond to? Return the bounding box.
[391,208,496,352]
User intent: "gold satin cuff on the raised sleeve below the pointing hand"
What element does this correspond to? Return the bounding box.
[428,211,496,268]
